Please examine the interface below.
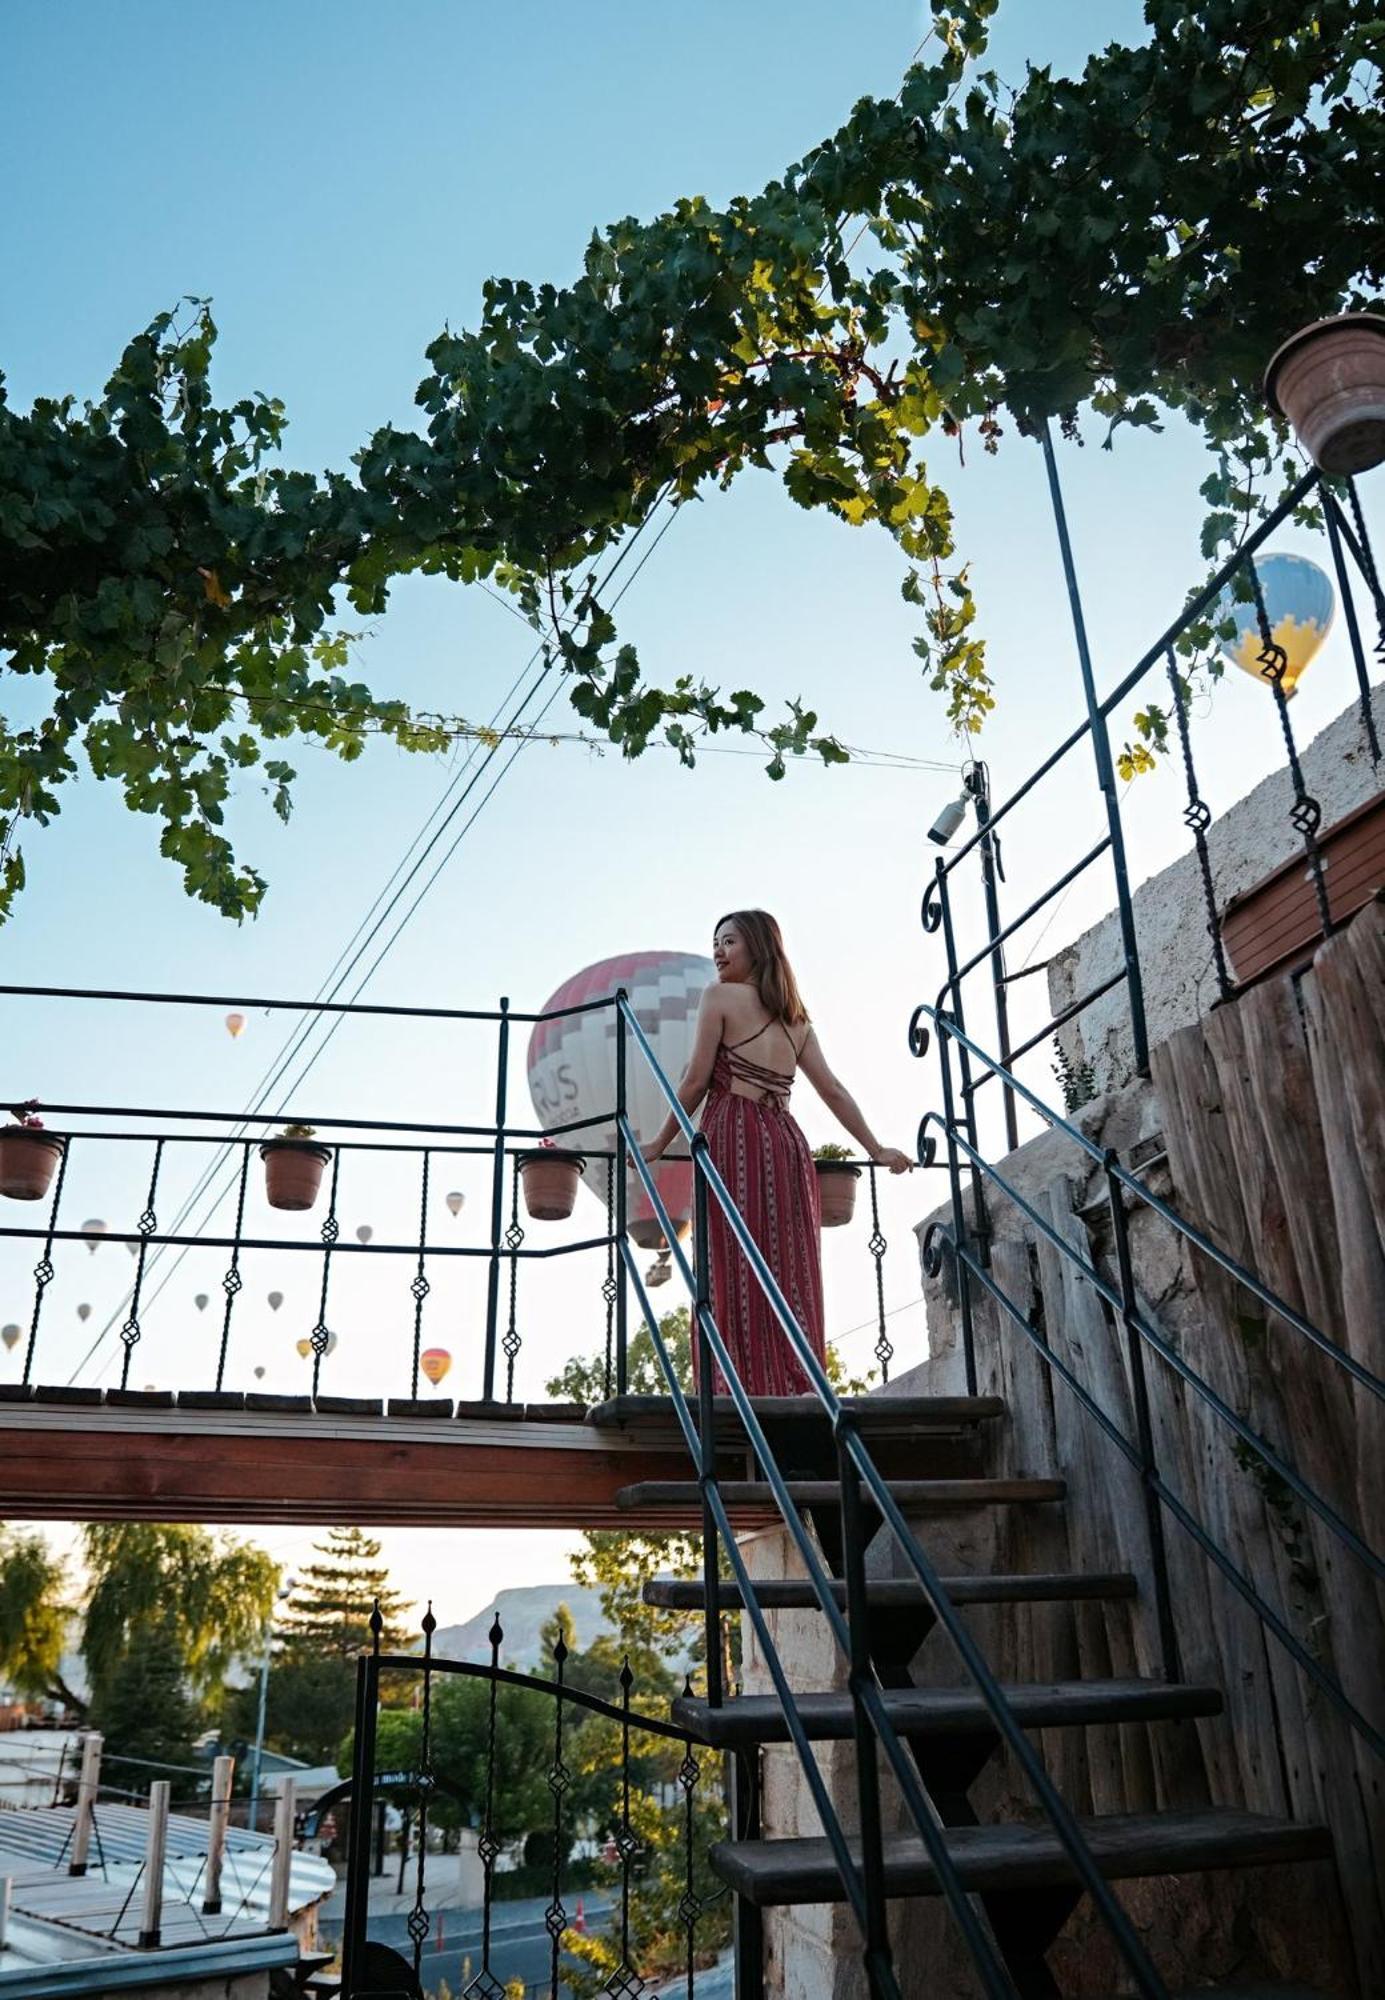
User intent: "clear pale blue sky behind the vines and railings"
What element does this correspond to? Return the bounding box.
[0,0,1349,1620]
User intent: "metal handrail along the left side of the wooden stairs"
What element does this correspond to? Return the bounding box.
[616,996,1167,2000]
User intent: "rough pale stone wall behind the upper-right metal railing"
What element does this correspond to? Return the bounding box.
[1049,682,1385,1090]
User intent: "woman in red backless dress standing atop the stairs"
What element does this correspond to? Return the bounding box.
[640,910,911,1396]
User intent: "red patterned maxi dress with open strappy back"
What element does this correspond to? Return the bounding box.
[693,1022,827,1396]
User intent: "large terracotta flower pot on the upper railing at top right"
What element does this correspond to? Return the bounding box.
[1265,312,1385,472]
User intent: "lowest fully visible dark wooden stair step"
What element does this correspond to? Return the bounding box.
[711,1808,1333,1906]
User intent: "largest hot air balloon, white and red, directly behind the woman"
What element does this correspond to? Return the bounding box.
[528,952,717,1250]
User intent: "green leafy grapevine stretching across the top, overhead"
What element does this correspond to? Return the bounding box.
[0,0,1385,918]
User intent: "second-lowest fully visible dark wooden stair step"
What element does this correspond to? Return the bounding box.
[670,1680,1221,1750]
